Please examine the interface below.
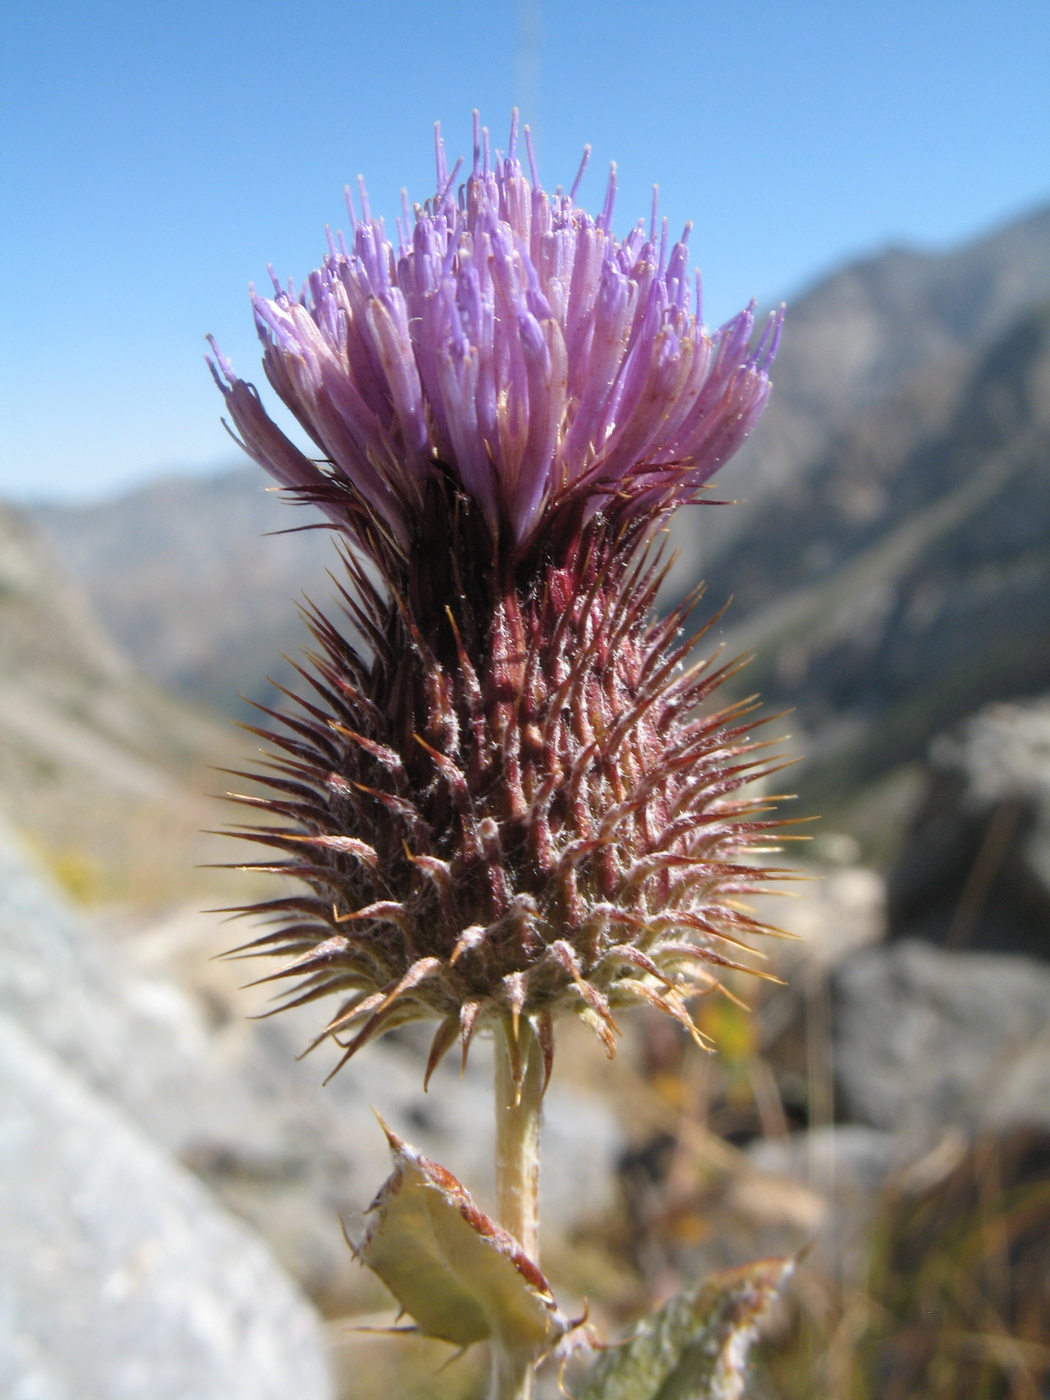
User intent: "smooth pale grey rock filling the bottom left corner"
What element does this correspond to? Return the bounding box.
[0,1018,330,1400]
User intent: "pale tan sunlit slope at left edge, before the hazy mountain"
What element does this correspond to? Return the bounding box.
[0,508,237,903]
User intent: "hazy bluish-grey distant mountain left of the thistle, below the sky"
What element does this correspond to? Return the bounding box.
[35,465,339,714]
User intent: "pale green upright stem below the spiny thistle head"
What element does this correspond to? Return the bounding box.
[489,1018,543,1400]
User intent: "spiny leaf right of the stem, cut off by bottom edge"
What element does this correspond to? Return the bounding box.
[578,1259,795,1400]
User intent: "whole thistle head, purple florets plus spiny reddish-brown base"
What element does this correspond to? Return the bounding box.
[211,119,780,1086]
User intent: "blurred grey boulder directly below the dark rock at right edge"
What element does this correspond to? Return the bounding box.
[832,941,1050,1145]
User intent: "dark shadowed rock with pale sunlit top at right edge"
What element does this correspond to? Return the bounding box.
[889,697,1050,958]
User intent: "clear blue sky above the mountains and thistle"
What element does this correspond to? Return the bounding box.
[0,0,1050,500]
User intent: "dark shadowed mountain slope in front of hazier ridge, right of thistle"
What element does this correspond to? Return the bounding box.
[720,305,1050,808]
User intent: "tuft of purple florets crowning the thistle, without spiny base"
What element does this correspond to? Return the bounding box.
[213,113,781,549]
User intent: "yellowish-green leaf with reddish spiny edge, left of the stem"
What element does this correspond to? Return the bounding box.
[358,1124,570,1357]
